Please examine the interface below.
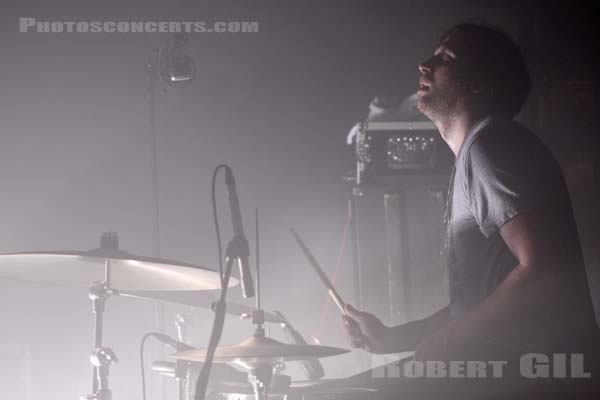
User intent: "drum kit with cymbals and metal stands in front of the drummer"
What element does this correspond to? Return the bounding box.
[0,233,370,400]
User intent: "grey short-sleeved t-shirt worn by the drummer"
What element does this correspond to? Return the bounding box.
[445,117,593,350]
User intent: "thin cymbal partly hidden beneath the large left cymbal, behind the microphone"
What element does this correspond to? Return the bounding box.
[119,290,285,324]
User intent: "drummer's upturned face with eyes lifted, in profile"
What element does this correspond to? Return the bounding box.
[417,36,465,121]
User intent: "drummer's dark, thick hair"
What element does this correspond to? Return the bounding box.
[439,21,531,118]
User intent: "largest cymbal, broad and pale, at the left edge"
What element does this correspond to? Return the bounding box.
[0,248,231,290]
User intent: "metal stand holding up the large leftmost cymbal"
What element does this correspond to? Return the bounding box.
[80,258,119,400]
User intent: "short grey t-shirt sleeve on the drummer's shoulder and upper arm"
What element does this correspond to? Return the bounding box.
[466,138,542,237]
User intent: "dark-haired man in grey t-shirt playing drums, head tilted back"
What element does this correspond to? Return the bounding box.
[344,22,600,398]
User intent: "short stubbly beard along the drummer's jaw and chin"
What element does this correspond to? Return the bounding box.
[417,82,461,122]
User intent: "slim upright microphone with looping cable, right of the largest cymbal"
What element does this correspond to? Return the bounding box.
[225,167,254,298]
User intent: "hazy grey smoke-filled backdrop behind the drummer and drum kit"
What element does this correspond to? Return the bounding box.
[0,0,600,400]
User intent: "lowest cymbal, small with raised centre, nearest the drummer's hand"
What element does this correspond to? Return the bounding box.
[172,336,348,363]
